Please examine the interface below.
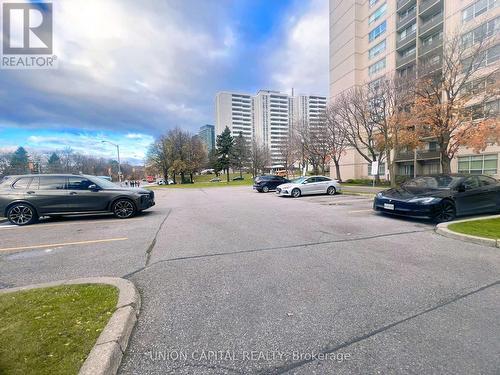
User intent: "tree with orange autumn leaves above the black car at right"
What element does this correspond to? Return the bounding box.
[412,33,500,173]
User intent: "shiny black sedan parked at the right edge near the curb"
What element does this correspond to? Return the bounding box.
[373,174,500,222]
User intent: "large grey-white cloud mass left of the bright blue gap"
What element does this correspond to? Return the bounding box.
[0,0,242,134]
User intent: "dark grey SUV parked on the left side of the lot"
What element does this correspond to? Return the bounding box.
[0,174,155,225]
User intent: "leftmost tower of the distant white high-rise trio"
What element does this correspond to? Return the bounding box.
[215,91,254,141]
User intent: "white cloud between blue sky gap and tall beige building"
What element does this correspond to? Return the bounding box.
[268,0,329,95]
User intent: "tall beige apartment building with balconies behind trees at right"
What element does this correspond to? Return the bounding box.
[330,0,500,179]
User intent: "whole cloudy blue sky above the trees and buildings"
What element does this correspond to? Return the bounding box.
[0,0,328,164]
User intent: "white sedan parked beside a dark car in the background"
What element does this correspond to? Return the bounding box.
[276,176,342,198]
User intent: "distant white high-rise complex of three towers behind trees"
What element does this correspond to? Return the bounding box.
[215,90,326,165]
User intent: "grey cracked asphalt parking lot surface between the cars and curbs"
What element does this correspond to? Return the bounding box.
[0,187,500,374]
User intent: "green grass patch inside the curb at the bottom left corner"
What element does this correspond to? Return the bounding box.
[0,284,118,375]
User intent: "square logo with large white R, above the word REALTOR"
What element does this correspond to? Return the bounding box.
[2,3,52,55]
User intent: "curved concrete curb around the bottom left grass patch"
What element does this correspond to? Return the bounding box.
[0,277,141,375]
